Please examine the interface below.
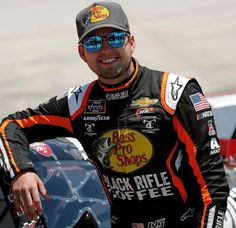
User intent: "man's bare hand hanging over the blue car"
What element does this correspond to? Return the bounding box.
[12,170,48,220]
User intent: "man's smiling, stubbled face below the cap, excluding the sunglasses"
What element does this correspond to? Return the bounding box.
[79,28,135,84]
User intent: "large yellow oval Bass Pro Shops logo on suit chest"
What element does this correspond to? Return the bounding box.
[94,128,153,173]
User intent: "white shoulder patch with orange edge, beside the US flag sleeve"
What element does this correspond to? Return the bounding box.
[161,73,191,115]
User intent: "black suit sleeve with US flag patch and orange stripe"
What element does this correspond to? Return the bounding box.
[173,80,229,228]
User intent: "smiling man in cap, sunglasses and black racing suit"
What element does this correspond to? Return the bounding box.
[0,2,228,228]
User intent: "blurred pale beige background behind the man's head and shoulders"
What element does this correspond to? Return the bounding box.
[0,0,236,119]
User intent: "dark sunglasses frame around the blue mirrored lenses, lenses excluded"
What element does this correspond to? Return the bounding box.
[78,31,130,53]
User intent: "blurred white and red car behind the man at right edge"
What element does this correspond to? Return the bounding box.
[208,92,236,228]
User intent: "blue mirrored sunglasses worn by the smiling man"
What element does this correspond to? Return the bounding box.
[79,32,129,53]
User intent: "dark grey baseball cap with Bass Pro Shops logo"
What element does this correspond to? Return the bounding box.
[76,2,130,41]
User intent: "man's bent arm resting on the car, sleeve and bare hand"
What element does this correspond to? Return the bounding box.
[0,94,73,219]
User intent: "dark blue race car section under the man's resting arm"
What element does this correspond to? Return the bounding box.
[0,138,110,228]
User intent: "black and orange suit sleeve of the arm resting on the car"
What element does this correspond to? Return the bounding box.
[0,96,73,178]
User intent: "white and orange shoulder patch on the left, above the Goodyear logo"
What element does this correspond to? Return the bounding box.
[68,81,95,120]
